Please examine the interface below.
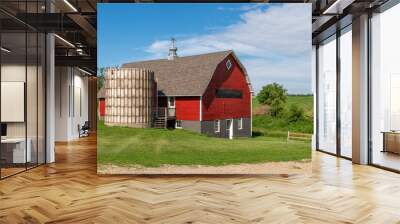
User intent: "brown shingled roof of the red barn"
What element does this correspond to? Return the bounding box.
[122,50,232,96]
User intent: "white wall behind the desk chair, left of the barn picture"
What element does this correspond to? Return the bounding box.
[55,67,88,141]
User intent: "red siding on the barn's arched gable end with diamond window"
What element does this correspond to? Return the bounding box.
[202,55,251,120]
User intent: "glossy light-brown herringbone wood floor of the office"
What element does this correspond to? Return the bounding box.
[0,138,400,224]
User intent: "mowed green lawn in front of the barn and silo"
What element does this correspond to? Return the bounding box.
[97,122,311,167]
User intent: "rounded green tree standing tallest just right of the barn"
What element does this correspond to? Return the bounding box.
[257,82,287,117]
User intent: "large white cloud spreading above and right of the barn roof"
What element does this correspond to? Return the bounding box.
[146,4,311,93]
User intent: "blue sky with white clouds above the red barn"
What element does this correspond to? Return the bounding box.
[97,3,311,93]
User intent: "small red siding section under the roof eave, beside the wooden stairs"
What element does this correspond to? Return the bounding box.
[175,96,200,121]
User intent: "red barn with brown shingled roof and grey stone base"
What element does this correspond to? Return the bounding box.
[120,48,252,138]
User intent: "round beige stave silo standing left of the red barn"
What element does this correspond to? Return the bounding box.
[104,68,156,128]
